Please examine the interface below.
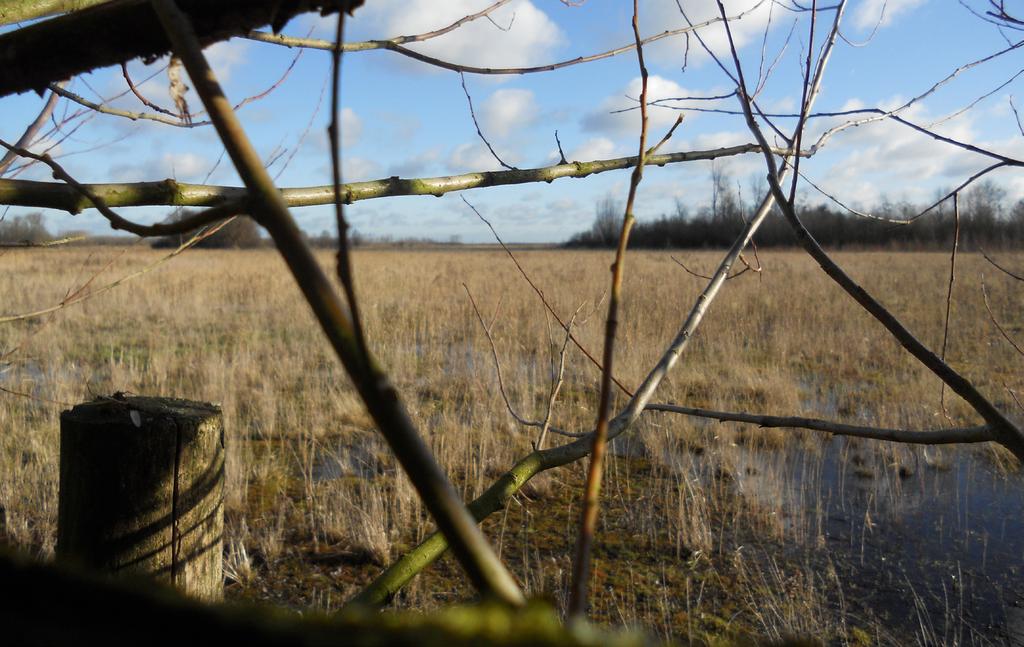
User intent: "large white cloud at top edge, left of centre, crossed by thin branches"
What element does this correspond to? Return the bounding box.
[352,0,565,67]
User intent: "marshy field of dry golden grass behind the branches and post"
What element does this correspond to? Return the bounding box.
[0,248,1024,644]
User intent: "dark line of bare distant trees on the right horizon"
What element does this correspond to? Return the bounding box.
[566,183,1024,250]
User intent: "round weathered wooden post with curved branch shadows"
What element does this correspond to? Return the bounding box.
[56,394,224,601]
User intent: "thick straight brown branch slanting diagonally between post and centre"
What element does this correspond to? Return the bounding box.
[153,0,524,604]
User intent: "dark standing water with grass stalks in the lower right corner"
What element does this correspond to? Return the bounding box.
[735,438,1024,645]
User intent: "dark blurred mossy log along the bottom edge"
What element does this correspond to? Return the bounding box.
[0,554,655,647]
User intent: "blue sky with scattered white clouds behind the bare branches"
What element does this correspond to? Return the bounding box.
[0,0,1024,242]
